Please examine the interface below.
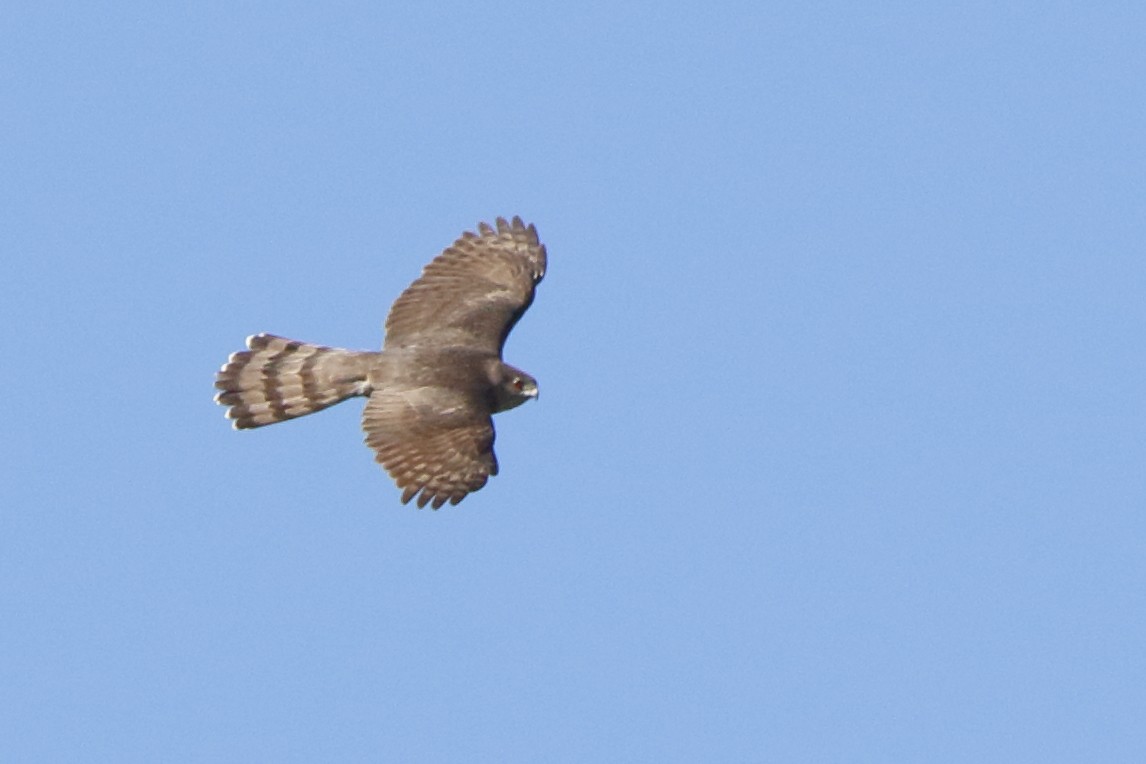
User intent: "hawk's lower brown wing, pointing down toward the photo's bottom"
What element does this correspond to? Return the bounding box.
[362,386,497,510]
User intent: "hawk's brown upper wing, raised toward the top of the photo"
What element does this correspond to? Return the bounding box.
[384,218,545,355]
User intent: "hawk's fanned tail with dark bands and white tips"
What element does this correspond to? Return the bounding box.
[215,334,378,430]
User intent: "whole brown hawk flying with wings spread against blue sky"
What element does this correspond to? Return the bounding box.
[215,218,545,510]
